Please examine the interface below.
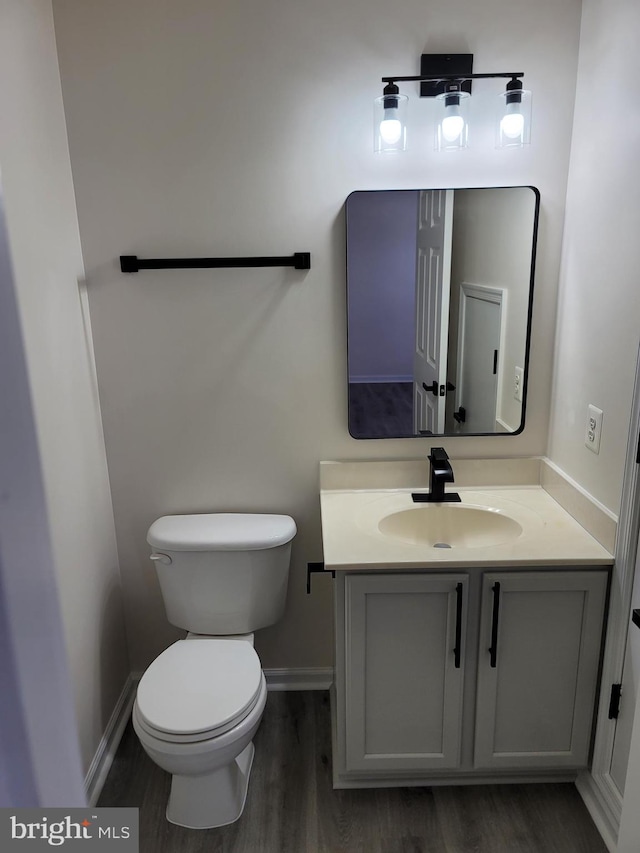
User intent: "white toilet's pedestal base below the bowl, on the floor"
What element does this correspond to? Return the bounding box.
[167,742,255,829]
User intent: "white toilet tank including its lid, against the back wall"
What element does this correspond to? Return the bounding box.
[147,513,296,635]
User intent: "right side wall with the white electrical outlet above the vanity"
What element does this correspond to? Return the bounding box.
[548,0,640,512]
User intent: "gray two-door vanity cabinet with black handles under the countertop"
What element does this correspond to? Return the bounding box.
[333,566,609,787]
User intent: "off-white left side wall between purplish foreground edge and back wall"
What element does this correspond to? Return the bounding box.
[0,0,129,771]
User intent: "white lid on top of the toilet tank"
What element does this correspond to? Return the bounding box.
[147,512,296,551]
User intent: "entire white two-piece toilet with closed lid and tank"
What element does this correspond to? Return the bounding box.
[133,513,296,829]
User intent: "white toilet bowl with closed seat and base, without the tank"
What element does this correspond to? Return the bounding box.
[133,638,267,829]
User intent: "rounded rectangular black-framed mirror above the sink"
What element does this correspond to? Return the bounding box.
[346,187,540,438]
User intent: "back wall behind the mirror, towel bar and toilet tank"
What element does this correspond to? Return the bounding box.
[54,0,580,667]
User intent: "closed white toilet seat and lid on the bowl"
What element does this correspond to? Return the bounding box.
[136,639,264,743]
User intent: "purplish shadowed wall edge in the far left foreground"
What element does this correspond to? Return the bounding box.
[0,185,85,808]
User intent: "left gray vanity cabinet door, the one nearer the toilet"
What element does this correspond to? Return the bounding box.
[345,574,467,772]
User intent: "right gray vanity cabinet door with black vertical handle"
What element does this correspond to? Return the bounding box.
[474,570,607,769]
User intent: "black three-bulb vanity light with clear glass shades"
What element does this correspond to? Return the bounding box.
[373,53,531,153]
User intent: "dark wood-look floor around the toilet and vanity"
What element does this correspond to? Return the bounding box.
[98,691,606,853]
